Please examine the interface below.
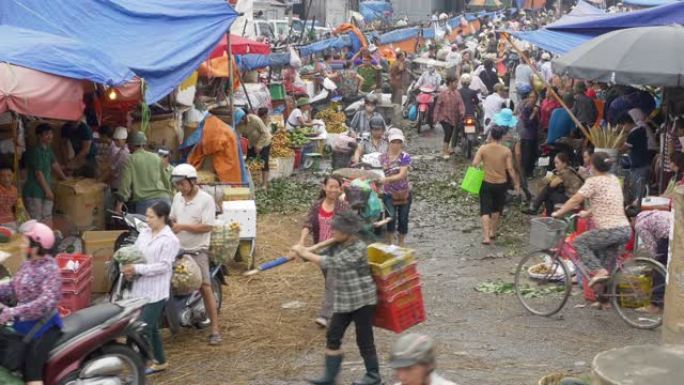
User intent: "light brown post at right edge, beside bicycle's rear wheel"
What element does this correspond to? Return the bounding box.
[662,187,684,344]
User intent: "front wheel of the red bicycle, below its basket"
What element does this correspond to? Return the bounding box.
[514,250,572,317]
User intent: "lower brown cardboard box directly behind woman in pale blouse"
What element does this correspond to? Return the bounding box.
[83,230,125,293]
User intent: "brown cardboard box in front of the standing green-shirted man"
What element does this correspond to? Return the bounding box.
[55,179,107,231]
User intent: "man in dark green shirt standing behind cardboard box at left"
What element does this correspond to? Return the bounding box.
[23,124,66,226]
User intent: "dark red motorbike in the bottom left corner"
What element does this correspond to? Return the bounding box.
[1,298,152,385]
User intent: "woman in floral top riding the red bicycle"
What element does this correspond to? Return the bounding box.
[552,152,632,287]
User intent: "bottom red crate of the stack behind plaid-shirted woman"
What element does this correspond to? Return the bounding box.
[373,285,425,333]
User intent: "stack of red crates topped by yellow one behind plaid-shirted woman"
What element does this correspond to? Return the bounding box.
[368,243,425,333]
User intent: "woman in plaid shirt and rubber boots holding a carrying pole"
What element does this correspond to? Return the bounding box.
[292,211,381,385]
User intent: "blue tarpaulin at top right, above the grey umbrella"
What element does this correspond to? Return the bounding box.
[511,2,684,54]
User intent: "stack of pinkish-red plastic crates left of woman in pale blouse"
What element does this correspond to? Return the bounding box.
[55,254,93,314]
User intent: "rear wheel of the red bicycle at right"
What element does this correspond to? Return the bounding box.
[609,258,667,329]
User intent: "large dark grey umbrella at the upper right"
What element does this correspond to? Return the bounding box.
[552,25,684,87]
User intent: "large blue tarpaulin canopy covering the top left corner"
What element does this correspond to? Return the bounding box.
[0,0,237,103]
